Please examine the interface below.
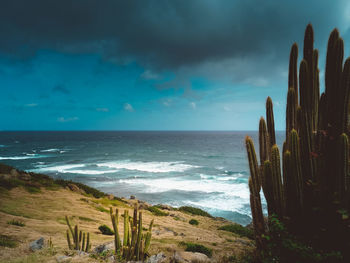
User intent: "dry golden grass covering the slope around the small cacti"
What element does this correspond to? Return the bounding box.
[0,187,252,263]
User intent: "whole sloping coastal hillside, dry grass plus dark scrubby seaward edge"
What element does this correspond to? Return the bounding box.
[0,163,254,263]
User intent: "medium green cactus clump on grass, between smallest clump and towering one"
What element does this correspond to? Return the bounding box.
[110,204,153,261]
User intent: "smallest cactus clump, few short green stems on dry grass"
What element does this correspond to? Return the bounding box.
[66,216,91,252]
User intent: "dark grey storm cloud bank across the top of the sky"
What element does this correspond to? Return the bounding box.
[0,0,347,77]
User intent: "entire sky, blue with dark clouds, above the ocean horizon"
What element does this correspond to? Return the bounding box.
[0,0,350,130]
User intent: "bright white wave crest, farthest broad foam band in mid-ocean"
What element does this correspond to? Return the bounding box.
[97,160,199,173]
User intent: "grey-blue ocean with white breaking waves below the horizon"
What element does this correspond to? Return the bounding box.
[0,131,284,225]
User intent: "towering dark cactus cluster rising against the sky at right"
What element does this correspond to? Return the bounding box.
[245,24,350,256]
